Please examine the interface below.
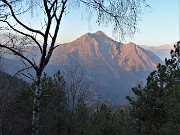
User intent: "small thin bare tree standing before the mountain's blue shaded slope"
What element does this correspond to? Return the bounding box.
[62,58,97,135]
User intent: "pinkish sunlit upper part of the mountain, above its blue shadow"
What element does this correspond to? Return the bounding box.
[51,31,161,71]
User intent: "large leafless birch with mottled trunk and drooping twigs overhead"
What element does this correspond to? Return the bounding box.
[0,0,148,135]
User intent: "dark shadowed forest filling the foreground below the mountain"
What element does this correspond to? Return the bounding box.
[0,42,180,135]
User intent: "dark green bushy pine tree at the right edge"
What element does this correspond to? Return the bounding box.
[127,42,180,135]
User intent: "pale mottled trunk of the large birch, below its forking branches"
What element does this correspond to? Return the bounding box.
[31,75,42,135]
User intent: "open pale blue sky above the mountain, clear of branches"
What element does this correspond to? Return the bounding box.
[58,0,180,45]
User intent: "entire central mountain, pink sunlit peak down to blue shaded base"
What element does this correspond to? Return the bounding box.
[0,31,162,104]
